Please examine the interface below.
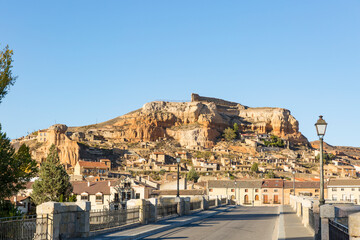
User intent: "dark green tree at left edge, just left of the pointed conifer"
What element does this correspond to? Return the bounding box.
[0,128,37,207]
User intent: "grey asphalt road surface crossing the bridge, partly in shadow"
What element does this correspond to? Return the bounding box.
[144,207,278,240]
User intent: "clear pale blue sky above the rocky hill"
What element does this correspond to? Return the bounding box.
[0,0,360,146]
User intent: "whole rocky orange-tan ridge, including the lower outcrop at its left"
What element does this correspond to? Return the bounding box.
[14,94,308,165]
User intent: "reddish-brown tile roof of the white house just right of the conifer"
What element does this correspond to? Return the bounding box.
[72,181,115,195]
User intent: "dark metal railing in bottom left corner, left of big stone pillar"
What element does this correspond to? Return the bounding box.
[0,215,53,240]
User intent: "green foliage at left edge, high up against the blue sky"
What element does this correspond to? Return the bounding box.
[0,46,17,103]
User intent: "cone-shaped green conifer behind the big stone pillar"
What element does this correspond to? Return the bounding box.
[31,144,72,205]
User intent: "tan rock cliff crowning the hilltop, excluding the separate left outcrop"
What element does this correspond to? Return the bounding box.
[71,94,307,147]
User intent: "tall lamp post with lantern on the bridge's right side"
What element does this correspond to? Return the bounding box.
[315,115,327,205]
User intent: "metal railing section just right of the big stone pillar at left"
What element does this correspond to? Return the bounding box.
[89,207,140,231]
